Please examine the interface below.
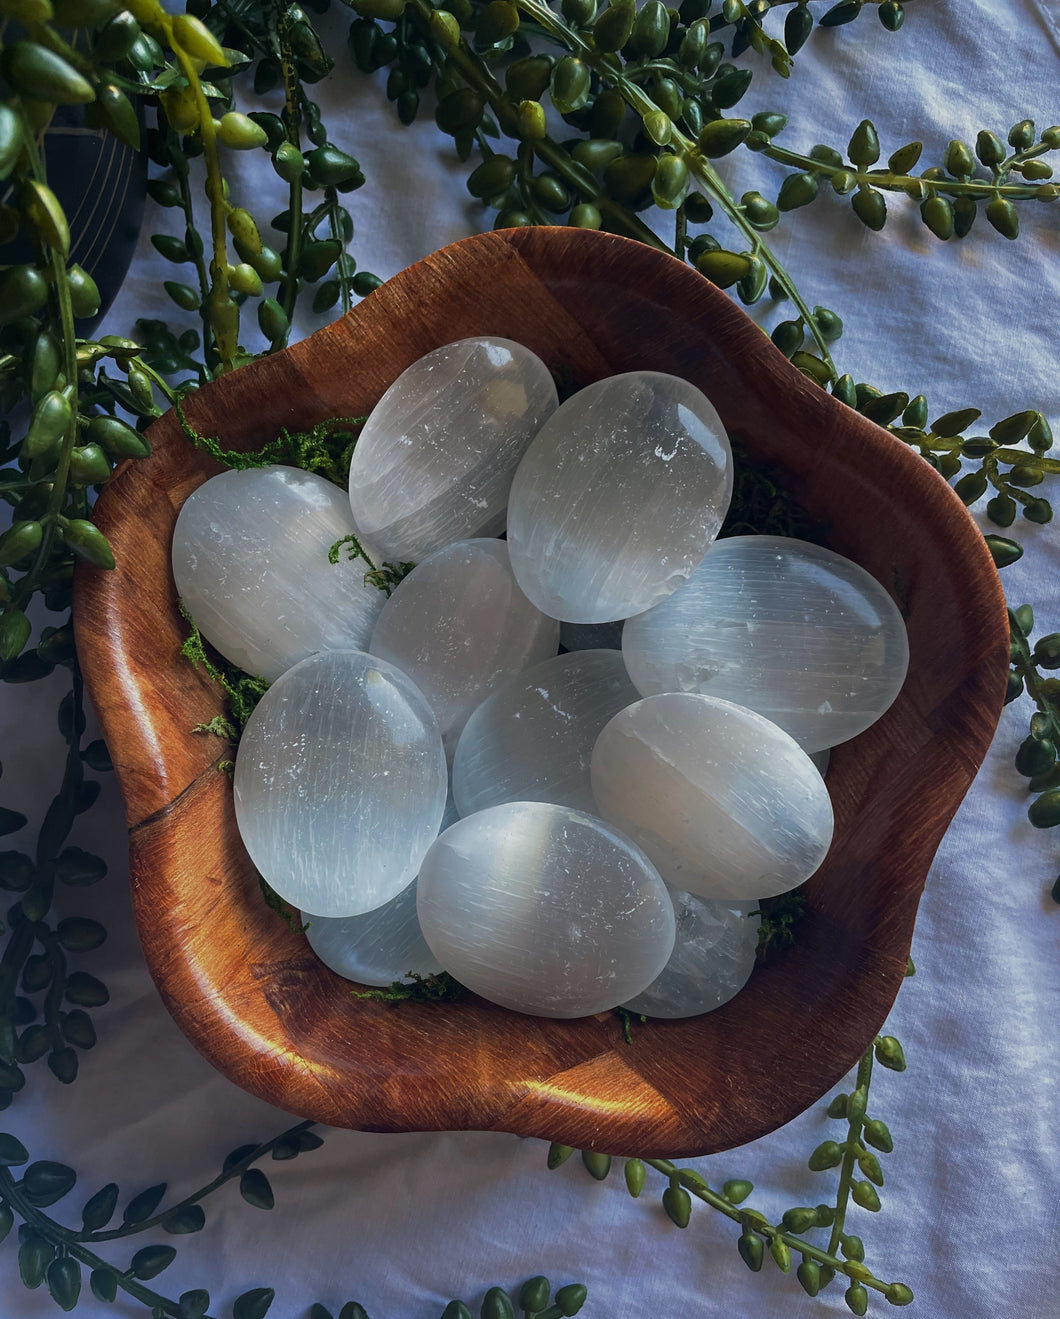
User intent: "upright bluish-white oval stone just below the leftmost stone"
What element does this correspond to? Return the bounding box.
[235,650,447,915]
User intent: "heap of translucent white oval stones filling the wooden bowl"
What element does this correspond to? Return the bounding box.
[174,338,908,1017]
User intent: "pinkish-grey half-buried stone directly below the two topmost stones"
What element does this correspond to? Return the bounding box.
[369,539,559,756]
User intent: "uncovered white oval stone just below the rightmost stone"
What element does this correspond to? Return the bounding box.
[592,692,833,901]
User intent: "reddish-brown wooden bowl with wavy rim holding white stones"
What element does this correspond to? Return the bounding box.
[75,228,1009,1157]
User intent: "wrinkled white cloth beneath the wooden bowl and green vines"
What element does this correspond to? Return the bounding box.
[0,0,1060,1319]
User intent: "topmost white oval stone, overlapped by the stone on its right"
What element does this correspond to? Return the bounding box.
[349,338,559,561]
